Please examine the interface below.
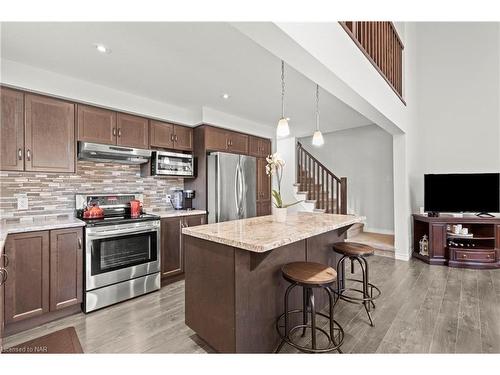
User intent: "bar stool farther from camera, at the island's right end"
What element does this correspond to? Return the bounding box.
[333,242,380,327]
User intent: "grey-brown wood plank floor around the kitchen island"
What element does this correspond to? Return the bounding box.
[4,256,500,353]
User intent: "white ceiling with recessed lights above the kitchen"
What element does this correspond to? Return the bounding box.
[1,22,371,136]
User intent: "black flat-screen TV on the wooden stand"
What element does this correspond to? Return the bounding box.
[424,173,500,213]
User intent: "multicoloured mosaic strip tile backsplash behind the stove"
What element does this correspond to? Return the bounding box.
[0,161,184,219]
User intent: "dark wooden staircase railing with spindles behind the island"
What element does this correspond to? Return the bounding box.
[296,142,347,214]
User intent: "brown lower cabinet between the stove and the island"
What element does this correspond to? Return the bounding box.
[161,215,206,280]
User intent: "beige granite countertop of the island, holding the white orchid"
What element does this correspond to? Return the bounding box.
[182,212,365,253]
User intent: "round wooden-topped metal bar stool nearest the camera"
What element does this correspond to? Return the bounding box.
[276,262,344,353]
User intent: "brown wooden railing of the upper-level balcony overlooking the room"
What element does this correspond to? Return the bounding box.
[340,21,406,104]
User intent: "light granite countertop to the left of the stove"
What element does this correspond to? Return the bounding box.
[0,216,85,248]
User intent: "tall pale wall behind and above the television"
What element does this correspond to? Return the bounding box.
[410,22,500,212]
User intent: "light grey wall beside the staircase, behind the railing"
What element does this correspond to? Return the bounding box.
[299,125,394,234]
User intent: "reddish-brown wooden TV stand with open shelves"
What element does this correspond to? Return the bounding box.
[413,214,500,268]
